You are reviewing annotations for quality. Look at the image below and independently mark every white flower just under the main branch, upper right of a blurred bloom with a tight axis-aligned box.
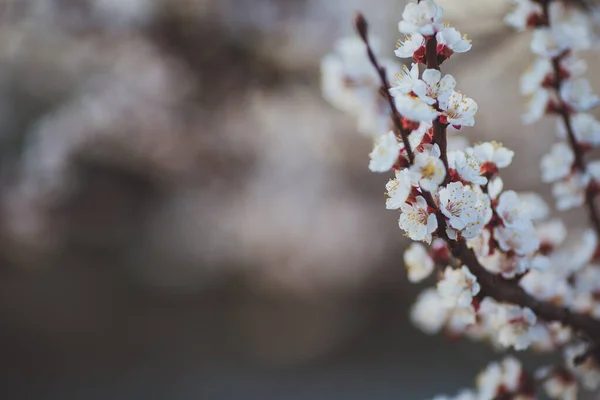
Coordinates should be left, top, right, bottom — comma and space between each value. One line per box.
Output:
437, 265, 481, 308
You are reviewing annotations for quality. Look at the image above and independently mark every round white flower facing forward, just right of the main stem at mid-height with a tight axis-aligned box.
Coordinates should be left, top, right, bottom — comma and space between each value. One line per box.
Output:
439, 182, 481, 230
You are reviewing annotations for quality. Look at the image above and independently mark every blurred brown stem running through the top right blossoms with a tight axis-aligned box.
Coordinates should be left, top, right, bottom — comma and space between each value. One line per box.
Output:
541, 0, 600, 237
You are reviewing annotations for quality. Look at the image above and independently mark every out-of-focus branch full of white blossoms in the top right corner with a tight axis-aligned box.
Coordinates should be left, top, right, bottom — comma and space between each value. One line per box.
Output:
506, 0, 600, 210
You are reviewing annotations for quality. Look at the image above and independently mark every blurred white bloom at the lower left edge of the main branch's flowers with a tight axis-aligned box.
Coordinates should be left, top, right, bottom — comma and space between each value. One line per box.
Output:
410, 288, 450, 335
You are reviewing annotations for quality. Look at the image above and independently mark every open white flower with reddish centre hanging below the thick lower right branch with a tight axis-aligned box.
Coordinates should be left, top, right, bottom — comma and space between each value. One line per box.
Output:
494, 304, 537, 350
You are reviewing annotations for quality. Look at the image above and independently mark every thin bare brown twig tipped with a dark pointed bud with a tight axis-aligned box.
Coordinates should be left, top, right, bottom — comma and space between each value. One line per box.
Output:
354, 13, 415, 163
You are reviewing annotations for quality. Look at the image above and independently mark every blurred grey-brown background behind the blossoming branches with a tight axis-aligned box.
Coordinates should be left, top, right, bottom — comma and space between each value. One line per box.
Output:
0, 0, 600, 400
